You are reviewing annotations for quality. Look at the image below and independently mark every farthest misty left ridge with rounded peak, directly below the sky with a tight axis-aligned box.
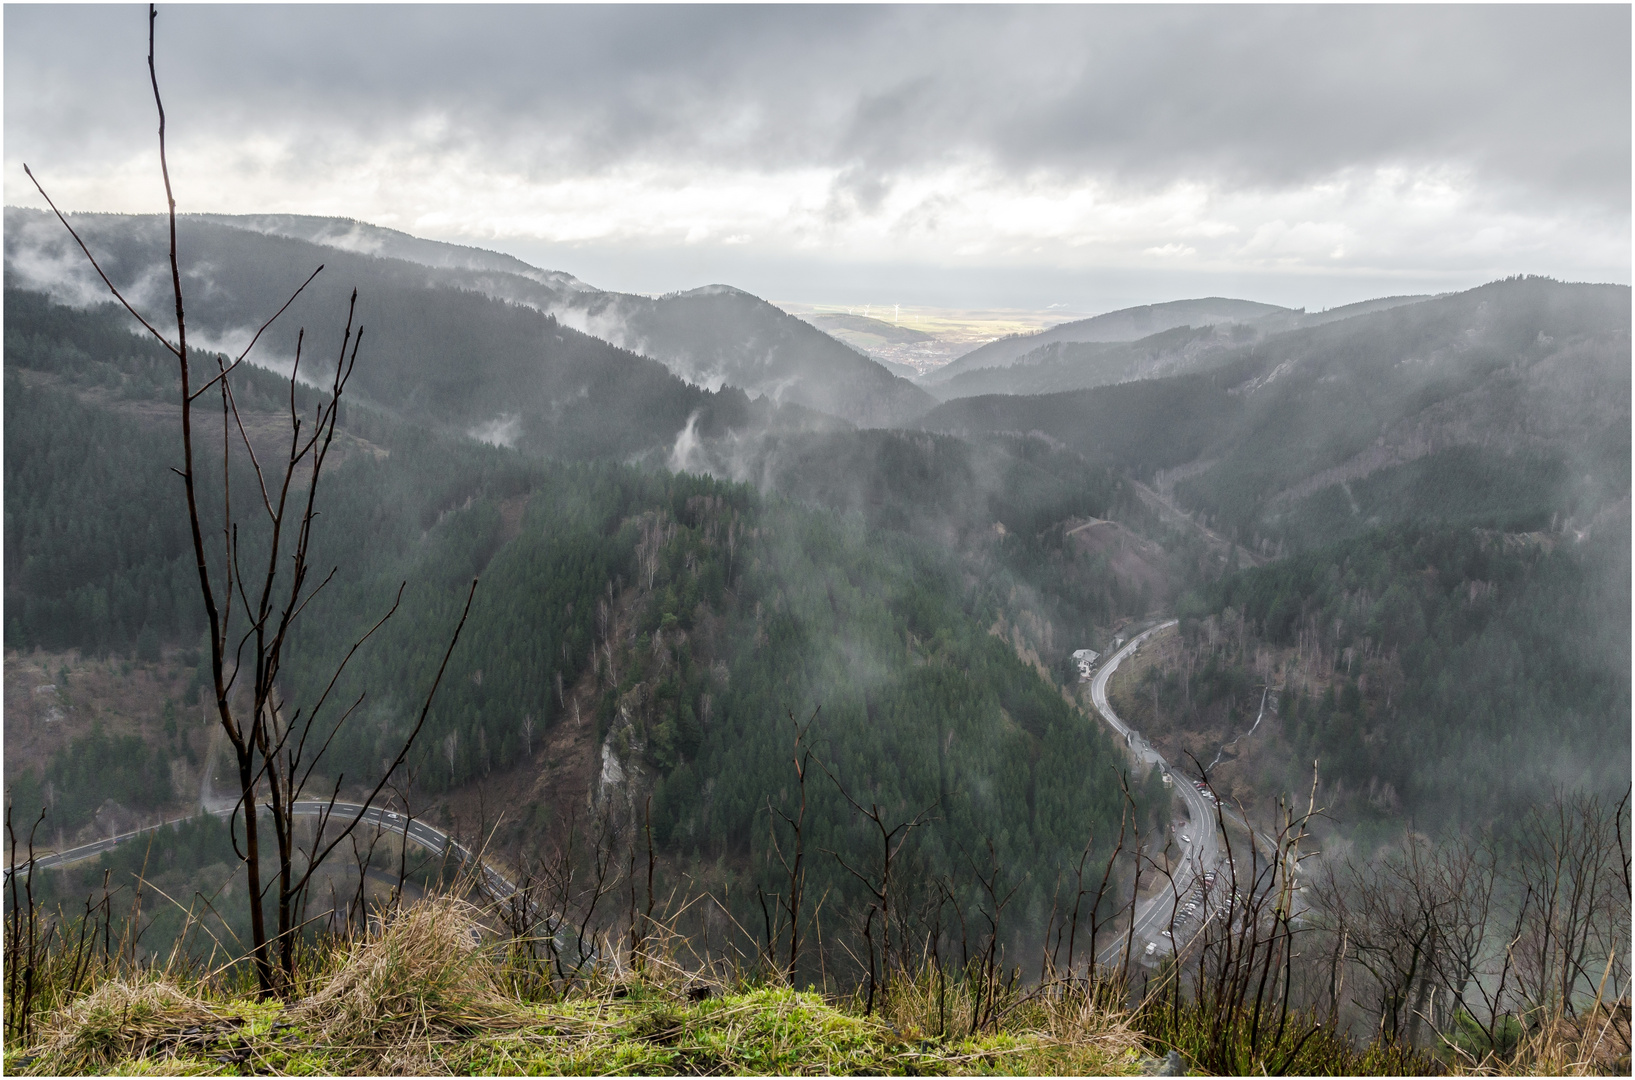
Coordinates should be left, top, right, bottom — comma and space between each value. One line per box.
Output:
31, 208, 935, 425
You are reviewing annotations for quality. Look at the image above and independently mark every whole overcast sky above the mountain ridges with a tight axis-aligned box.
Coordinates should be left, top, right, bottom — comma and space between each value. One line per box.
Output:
5, 5, 1630, 312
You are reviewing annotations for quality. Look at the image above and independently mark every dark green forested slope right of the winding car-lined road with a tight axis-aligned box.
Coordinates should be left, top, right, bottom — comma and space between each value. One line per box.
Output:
1157, 519, 1630, 837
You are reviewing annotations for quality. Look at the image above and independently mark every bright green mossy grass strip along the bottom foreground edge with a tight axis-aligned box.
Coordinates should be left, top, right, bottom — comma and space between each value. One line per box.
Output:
5, 982, 1141, 1077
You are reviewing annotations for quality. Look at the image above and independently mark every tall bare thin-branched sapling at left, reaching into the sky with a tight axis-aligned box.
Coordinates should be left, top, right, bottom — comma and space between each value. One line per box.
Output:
25, 5, 477, 995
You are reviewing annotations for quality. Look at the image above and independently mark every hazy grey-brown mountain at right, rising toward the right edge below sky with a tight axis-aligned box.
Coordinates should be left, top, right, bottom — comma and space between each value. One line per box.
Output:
922, 278, 1630, 542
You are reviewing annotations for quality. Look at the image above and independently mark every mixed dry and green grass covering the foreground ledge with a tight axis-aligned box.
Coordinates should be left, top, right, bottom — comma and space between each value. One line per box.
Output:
5, 895, 1628, 1075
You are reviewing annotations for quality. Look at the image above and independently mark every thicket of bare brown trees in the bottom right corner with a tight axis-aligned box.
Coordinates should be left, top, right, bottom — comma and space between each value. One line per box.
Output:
1313, 794, 1630, 1069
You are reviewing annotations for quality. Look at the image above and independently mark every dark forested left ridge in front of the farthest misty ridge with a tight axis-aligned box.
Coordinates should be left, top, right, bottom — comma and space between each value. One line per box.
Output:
5, 211, 767, 457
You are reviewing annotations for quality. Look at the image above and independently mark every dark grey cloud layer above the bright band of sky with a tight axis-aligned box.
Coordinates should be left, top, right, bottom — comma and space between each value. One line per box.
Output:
5, 5, 1630, 219
